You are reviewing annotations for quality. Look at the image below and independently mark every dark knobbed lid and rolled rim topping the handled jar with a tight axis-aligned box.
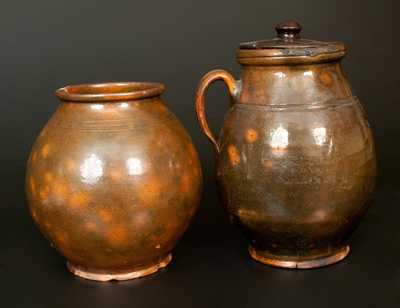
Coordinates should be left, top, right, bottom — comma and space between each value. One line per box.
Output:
238, 20, 346, 64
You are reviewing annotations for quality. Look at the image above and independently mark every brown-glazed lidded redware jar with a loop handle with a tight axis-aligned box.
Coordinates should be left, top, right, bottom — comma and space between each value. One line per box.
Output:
196, 21, 376, 268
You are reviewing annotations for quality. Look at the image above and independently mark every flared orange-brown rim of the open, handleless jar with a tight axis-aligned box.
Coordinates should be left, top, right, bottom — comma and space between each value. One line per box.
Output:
55, 82, 165, 102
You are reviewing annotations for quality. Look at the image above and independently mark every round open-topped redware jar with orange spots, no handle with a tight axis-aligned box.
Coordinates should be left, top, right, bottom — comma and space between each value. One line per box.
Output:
26, 82, 202, 281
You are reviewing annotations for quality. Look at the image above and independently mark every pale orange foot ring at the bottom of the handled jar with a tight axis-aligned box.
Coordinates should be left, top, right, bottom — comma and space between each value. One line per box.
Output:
249, 245, 350, 269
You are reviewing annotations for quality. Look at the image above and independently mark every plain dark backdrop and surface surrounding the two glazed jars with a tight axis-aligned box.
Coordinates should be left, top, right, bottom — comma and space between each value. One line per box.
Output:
0, 0, 400, 308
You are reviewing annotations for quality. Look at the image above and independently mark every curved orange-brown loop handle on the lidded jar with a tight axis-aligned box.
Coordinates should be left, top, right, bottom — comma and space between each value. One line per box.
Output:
196, 70, 239, 154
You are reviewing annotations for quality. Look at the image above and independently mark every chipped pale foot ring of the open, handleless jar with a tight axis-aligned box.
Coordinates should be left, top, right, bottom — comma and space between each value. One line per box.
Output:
67, 254, 172, 281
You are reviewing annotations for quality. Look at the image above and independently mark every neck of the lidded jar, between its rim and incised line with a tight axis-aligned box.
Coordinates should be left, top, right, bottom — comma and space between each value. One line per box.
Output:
238, 61, 352, 105
